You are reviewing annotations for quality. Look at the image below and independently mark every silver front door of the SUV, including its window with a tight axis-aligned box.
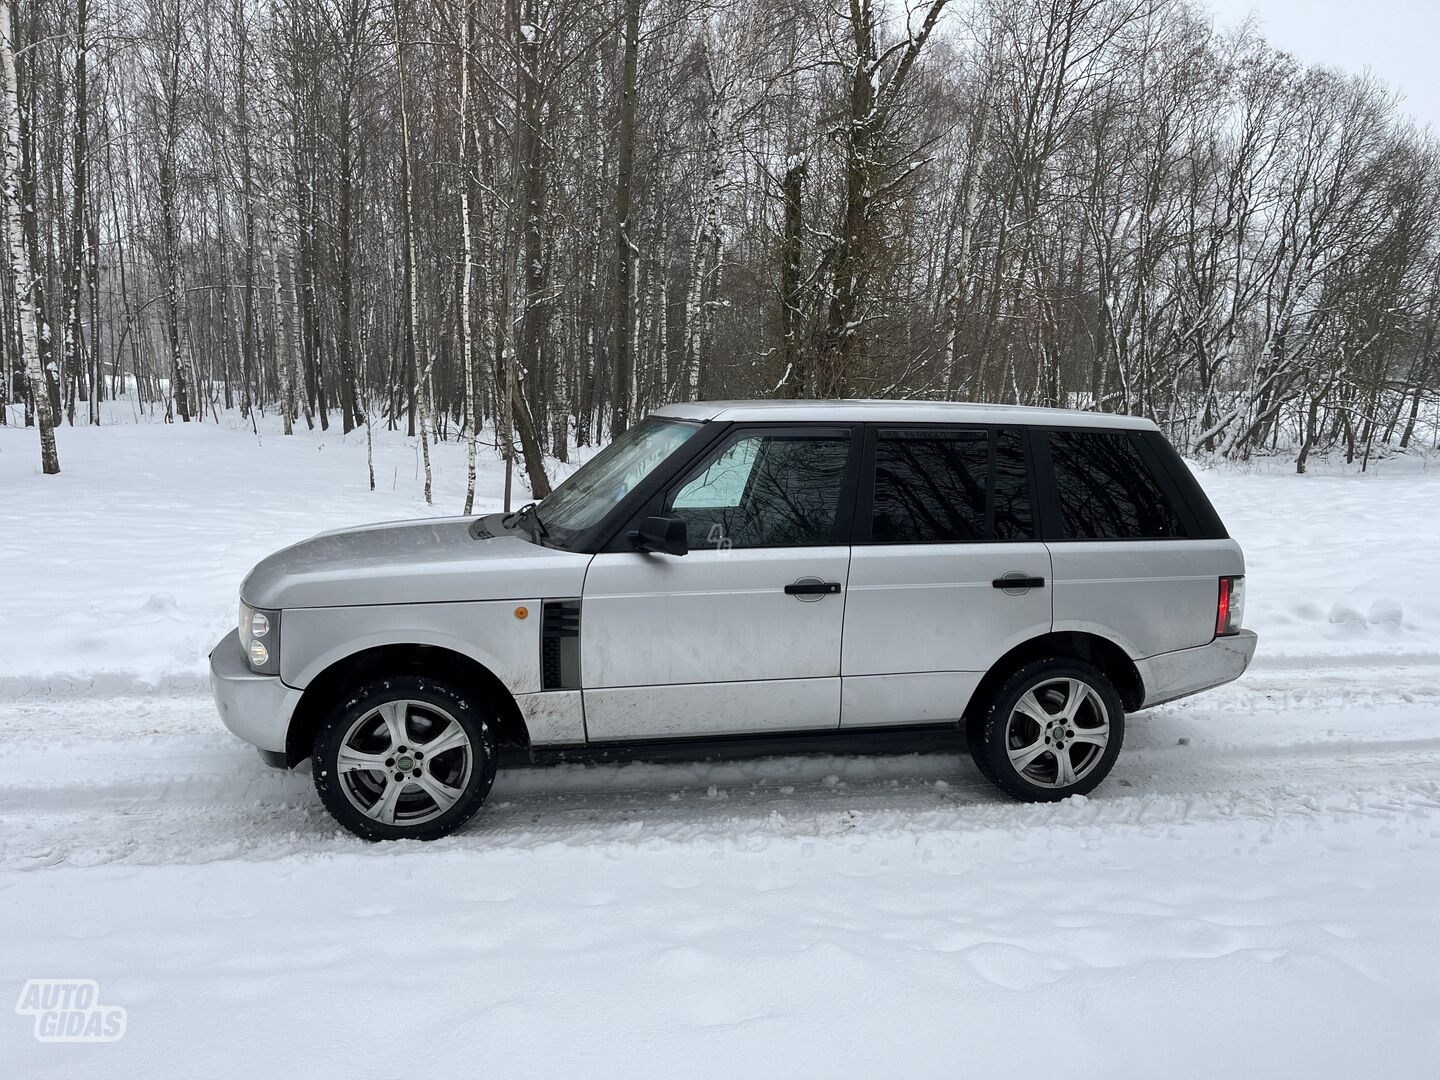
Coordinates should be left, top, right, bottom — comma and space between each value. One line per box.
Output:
580, 426, 857, 742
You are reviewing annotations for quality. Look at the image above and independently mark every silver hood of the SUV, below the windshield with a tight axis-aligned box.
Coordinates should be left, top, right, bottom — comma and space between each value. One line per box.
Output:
240, 516, 590, 609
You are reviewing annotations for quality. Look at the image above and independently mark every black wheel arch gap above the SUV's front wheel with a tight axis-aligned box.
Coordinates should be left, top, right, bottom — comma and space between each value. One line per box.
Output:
285, 645, 530, 769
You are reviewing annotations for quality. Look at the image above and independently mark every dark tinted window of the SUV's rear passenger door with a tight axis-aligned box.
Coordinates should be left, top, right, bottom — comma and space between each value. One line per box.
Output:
870, 428, 1031, 544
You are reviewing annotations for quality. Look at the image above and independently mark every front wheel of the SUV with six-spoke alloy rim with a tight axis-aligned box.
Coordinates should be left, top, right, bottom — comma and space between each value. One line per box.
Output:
314, 675, 497, 840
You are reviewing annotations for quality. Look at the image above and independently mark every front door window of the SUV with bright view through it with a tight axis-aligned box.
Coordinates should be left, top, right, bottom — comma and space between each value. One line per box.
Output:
665, 433, 850, 547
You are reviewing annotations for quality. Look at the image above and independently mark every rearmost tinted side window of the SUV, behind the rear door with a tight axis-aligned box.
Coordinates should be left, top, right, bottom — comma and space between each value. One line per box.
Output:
1048, 431, 1185, 540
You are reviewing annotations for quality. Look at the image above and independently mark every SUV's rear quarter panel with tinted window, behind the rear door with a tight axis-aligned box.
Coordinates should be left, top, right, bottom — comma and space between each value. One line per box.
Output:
1035, 429, 1243, 660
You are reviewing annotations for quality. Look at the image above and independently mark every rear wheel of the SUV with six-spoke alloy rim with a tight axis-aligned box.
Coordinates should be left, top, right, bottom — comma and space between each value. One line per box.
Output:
971, 658, 1125, 802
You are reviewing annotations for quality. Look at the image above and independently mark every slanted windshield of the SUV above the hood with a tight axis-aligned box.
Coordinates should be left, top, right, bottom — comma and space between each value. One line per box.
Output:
539, 416, 700, 544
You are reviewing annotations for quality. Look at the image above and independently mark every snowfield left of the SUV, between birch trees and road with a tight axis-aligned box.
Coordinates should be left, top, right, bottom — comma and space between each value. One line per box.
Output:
0, 408, 555, 690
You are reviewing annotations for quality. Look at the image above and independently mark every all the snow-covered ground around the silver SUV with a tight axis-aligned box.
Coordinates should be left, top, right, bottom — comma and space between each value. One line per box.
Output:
0, 408, 1440, 1080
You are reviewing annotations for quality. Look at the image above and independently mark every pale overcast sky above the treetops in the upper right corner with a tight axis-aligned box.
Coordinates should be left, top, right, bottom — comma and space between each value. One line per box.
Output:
1208, 0, 1440, 131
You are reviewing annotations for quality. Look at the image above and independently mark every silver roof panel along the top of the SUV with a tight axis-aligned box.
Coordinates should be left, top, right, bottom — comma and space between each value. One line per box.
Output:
652, 397, 1156, 431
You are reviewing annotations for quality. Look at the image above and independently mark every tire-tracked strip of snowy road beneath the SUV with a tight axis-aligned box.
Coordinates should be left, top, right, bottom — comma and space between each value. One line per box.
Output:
0, 691, 1440, 870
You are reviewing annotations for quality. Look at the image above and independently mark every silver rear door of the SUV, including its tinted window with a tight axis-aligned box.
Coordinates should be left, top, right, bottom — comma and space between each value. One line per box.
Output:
841, 426, 1051, 727
